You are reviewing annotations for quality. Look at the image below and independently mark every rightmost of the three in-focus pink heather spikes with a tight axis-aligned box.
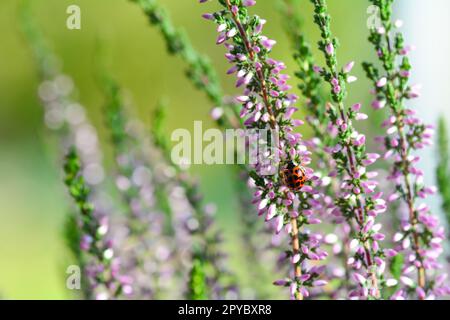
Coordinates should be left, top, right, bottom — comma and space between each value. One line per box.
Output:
363, 0, 445, 300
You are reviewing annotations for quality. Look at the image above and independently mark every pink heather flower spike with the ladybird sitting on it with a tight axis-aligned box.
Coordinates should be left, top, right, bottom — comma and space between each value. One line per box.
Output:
200, 0, 327, 299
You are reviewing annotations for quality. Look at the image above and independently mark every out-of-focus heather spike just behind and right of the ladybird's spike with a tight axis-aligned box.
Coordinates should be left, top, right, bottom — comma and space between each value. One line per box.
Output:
280, 0, 353, 298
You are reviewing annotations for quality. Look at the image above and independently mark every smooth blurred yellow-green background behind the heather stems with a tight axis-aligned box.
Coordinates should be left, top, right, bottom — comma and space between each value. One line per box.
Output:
0, 0, 442, 299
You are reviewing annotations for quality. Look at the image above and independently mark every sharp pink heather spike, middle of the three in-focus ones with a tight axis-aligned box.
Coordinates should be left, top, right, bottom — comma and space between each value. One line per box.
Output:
311, 0, 386, 299
